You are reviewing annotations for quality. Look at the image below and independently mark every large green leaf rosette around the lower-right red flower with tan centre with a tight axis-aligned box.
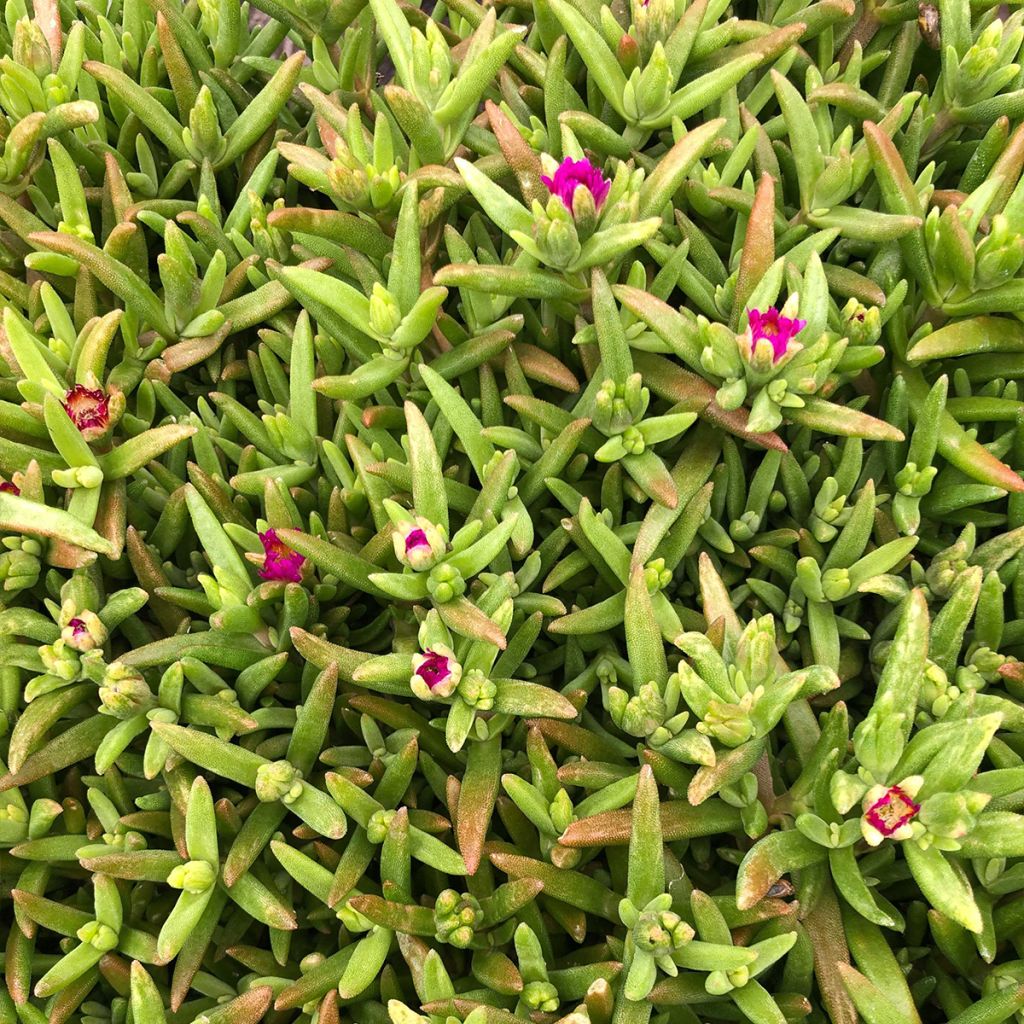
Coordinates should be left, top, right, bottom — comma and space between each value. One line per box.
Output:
737, 591, 1020, 933
